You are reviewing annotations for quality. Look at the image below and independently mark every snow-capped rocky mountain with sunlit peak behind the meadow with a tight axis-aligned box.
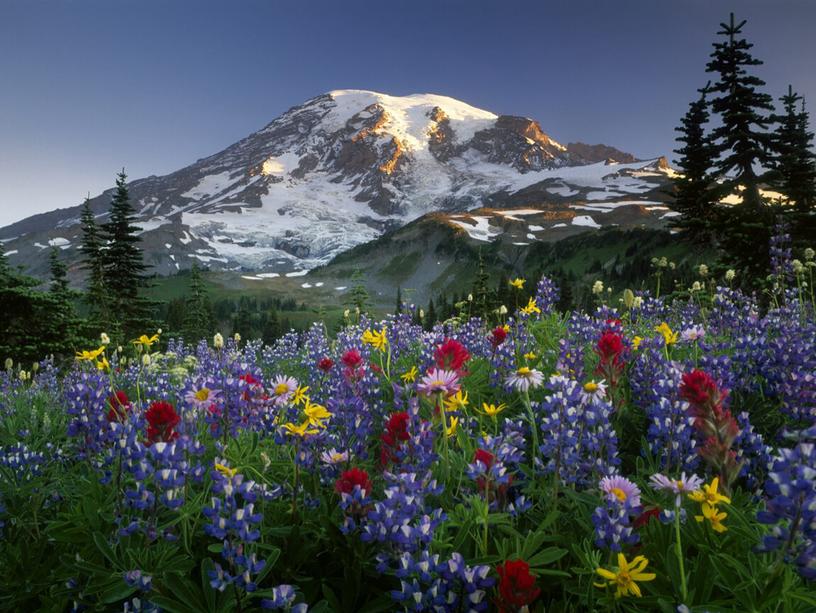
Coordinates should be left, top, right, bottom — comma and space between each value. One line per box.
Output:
0, 90, 670, 273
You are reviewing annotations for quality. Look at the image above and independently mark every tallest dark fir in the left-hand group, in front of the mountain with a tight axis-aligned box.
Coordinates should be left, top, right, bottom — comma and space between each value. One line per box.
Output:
101, 169, 155, 338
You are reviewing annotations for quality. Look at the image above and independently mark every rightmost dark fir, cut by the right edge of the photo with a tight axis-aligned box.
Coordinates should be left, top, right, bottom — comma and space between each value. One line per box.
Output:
773, 85, 816, 213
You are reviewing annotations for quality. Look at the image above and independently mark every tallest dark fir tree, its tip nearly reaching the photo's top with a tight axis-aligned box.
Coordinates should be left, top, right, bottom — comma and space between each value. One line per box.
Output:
706, 13, 774, 210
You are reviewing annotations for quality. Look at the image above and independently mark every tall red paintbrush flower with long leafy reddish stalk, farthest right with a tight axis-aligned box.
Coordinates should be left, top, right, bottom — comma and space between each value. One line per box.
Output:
680, 370, 742, 491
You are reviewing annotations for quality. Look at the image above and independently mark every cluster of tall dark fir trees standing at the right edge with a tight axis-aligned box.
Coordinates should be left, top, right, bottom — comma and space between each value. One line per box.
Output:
673, 13, 816, 288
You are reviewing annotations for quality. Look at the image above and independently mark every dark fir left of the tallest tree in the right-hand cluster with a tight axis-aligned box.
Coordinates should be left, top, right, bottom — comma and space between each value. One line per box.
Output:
670, 86, 717, 242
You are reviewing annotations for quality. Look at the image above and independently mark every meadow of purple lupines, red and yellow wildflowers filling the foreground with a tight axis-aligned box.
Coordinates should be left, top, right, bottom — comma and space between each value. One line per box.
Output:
0, 250, 816, 612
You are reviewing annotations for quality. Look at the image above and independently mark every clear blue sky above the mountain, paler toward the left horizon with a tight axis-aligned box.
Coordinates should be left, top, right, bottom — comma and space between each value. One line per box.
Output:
0, 0, 816, 225
